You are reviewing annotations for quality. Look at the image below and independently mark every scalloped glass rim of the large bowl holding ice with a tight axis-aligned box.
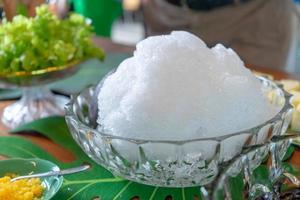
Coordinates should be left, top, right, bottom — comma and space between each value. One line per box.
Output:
65, 76, 293, 144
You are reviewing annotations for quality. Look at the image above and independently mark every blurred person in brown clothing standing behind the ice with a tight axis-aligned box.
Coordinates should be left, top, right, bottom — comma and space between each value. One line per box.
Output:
142, 0, 292, 68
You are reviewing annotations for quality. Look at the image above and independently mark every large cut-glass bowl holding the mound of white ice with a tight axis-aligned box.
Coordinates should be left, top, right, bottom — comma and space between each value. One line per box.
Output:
66, 77, 292, 187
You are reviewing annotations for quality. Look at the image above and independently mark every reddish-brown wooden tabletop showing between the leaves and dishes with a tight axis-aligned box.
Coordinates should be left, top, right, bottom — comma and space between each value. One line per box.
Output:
0, 38, 300, 175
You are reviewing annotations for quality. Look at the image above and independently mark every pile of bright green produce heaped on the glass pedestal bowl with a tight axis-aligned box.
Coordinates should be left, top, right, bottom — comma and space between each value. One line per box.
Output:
0, 5, 104, 73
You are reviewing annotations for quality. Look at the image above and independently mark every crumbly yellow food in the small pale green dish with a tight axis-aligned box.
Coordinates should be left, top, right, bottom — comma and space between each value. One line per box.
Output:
0, 175, 44, 200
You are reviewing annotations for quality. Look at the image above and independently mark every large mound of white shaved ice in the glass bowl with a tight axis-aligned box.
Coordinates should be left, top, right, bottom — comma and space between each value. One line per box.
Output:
97, 31, 279, 140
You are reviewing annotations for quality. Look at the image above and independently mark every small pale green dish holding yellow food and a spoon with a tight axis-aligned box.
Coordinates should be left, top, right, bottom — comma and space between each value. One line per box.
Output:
0, 158, 63, 200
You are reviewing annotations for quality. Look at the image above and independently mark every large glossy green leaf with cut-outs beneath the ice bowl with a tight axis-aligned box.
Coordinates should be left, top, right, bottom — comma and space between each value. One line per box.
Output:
0, 117, 300, 200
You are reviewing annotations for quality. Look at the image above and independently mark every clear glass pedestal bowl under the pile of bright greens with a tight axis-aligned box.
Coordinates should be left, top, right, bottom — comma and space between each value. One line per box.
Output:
0, 61, 79, 128
